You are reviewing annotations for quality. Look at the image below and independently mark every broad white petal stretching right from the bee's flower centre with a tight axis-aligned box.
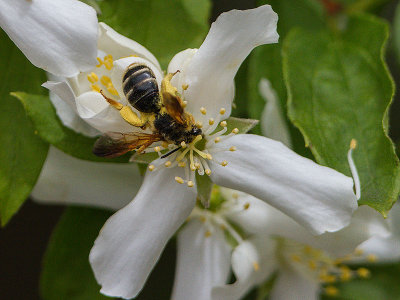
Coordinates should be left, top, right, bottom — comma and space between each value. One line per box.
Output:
210, 134, 357, 234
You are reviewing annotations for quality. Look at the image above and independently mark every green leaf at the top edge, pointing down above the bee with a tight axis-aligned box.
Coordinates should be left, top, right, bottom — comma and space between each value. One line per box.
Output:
99, 0, 211, 69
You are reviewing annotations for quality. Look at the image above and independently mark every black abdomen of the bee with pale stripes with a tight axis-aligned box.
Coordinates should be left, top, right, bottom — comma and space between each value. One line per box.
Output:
122, 63, 161, 113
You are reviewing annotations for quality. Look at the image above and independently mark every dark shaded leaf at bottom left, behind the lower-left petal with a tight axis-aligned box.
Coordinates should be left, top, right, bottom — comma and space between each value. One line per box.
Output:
40, 207, 111, 300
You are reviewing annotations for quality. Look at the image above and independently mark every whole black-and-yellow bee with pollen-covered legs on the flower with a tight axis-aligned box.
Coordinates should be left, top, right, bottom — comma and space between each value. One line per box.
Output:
93, 63, 202, 157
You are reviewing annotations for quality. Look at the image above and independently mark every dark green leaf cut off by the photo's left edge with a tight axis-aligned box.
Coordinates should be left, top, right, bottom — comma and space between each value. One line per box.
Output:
0, 30, 48, 226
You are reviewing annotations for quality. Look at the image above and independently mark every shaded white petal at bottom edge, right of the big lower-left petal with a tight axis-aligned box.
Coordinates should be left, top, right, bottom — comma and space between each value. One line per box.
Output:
172, 219, 231, 300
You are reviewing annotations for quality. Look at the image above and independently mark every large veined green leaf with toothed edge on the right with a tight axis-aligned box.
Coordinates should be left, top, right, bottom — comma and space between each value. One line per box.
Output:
283, 15, 400, 214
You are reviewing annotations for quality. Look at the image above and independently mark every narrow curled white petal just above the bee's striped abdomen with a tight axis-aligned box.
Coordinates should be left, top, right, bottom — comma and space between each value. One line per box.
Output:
98, 22, 161, 70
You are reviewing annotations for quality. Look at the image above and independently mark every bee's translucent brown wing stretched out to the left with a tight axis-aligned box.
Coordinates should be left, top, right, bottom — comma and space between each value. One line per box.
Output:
93, 132, 161, 158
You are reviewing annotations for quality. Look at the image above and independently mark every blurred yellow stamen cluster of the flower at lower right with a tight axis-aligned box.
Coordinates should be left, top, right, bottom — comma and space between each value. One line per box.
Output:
284, 240, 376, 296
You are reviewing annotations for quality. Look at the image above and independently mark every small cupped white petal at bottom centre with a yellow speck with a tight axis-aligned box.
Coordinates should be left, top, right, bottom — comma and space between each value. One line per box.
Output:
212, 236, 277, 300
